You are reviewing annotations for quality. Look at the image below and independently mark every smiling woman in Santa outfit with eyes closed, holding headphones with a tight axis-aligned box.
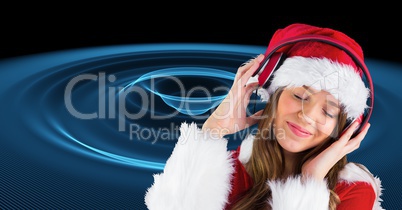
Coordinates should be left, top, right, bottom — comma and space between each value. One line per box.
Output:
145, 24, 382, 210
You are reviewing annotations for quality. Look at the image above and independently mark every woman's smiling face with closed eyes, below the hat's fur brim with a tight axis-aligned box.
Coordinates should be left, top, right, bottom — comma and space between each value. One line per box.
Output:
274, 86, 340, 153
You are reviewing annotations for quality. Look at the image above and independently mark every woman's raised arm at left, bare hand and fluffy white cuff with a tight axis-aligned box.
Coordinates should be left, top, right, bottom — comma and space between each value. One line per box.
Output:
145, 55, 264, 210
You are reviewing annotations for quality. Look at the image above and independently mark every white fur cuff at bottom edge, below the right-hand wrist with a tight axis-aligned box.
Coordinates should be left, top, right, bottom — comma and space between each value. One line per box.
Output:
268, 176, 330, 210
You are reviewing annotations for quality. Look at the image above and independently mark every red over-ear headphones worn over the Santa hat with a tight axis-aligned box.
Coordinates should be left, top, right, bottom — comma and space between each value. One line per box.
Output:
253, 35, 374, 138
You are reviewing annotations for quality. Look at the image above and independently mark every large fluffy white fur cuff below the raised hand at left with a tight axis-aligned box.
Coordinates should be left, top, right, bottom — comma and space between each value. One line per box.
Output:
145, 123, 234, 210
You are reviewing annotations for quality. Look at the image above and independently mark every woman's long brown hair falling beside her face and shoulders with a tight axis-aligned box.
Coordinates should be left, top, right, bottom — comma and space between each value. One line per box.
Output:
232, 88, 347, 210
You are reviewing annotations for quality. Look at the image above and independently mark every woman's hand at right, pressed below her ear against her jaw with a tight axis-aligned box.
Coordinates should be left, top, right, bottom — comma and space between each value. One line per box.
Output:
302, 122, 370, 180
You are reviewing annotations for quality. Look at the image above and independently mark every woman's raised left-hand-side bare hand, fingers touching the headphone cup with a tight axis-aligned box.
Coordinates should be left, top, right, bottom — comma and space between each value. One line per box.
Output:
202, 55, 264, 137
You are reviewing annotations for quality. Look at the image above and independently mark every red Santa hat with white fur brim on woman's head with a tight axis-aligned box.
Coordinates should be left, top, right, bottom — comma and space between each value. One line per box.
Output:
254, 23, 370, 119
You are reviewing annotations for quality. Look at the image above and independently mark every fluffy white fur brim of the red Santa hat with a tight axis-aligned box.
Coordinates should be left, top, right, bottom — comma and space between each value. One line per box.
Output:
257, 56, 370, 119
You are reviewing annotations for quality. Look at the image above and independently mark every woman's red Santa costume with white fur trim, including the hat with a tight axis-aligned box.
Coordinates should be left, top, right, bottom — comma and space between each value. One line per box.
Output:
145, 24, 383, 210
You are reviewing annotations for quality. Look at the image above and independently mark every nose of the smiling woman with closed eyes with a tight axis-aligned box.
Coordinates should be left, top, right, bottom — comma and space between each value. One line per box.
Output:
298, 103, 325, 126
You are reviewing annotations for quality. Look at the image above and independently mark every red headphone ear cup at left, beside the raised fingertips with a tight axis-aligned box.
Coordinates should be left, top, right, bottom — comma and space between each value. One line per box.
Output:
258, 52, 286, 88
